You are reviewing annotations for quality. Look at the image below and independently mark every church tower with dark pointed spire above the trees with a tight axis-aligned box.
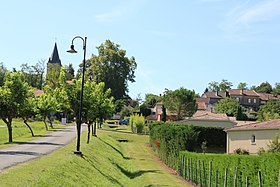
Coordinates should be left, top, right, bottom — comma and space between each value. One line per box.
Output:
46, 42, 61, 88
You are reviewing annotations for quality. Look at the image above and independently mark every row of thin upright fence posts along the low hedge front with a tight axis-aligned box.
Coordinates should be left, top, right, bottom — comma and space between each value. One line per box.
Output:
179, 155, 280, 187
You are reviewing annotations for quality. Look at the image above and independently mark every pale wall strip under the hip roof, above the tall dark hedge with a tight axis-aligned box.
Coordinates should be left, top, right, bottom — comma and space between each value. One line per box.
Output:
179, 119, 235, 129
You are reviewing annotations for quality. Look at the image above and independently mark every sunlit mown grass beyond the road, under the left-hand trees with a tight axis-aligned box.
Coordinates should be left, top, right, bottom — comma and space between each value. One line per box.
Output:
0, 119, 68, 148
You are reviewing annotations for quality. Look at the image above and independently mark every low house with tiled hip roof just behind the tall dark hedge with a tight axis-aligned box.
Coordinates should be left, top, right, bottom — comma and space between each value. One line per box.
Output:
176, 111, 236, 129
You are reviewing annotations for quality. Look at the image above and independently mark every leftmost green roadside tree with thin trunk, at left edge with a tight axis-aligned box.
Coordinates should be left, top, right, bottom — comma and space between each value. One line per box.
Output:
0, 72, 29, 142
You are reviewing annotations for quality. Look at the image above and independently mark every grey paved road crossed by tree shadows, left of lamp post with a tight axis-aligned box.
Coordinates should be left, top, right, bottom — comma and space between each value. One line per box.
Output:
0, 126, 85, 172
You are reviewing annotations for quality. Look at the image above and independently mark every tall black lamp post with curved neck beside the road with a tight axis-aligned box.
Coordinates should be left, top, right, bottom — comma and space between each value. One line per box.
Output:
67, 36, 87, 155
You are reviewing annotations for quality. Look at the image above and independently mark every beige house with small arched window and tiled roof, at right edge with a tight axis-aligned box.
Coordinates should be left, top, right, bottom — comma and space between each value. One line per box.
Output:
225, 120, 280, 154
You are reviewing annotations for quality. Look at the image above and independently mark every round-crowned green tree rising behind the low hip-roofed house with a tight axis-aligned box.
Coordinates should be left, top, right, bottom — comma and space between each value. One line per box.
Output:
163, 87, 197, 120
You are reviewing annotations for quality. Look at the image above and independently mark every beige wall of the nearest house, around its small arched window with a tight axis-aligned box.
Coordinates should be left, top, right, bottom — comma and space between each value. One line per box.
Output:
227, 129, 280, 154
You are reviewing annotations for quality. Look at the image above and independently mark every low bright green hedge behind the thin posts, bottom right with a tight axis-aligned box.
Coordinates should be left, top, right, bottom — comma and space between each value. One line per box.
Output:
178, 151, 280, 186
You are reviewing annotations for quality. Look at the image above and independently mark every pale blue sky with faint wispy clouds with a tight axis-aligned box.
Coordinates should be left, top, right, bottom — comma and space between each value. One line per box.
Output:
0, 0, 280, 99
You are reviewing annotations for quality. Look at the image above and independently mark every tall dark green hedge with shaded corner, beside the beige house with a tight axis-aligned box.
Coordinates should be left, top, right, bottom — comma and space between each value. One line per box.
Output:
149, 122, 226, 169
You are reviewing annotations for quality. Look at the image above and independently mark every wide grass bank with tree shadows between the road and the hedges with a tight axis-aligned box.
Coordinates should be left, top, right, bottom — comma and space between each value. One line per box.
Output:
0, 130, 188, 187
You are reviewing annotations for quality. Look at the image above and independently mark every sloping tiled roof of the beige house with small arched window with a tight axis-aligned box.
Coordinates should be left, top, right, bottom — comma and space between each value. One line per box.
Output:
227, 119, 280, 131
